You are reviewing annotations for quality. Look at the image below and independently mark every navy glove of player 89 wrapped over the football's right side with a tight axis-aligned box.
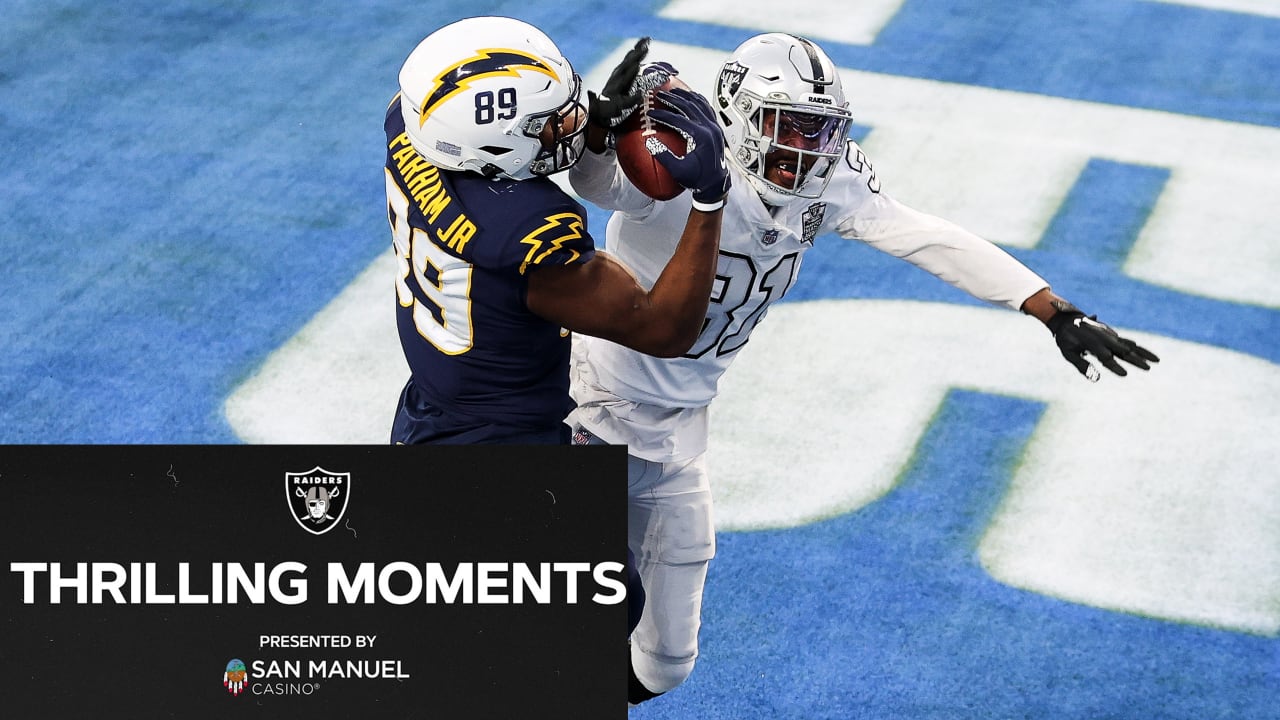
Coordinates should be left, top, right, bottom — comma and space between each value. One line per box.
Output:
645, 87, 730, 209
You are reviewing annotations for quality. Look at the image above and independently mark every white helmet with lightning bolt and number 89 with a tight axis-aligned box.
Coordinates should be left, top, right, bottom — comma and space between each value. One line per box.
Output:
399, 17, 586, 179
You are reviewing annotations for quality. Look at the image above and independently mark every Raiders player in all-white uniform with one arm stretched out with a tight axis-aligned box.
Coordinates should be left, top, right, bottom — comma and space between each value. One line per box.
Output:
566, 33, 1158, 703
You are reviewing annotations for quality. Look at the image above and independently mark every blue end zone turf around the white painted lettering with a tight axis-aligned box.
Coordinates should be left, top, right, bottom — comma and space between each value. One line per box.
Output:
0, 0, 1280, 720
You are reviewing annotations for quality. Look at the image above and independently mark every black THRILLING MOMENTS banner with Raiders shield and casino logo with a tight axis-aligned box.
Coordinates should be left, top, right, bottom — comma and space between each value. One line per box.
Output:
0, 446, 626, 719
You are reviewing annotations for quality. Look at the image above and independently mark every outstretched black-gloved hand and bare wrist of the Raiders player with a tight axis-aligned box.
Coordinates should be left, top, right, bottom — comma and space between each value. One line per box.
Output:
1023, 288, 1160, 382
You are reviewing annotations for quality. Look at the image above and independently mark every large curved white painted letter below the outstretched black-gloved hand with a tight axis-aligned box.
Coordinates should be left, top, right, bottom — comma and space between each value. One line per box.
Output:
708, 300, 1280, 635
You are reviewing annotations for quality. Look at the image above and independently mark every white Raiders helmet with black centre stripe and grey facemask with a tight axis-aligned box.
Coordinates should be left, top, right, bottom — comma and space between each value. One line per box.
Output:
716, 32, 851, 205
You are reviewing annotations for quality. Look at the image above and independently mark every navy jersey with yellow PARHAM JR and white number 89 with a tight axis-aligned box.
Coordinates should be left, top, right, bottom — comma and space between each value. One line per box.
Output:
385, 101, 595, 442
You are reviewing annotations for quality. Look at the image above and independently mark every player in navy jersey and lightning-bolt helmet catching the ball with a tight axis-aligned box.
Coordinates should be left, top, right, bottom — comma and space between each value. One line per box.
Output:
385, 17, 728, 445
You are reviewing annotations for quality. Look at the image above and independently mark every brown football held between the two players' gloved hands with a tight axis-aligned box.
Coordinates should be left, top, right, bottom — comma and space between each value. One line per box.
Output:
613, 63, 706, 200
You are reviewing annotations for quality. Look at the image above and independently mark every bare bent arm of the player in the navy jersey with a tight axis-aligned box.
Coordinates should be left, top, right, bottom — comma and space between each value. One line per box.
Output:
526, 209, 723, 357
